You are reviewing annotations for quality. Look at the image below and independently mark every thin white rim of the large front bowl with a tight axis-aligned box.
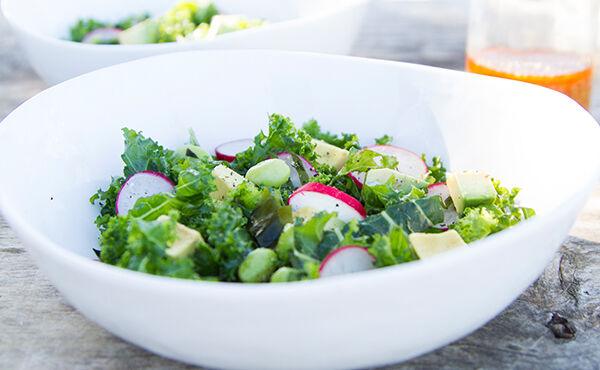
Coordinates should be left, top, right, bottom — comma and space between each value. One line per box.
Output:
0, 50, 600, 295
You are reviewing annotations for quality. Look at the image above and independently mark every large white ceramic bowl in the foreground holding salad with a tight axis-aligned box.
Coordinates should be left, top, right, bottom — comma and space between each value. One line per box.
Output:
0, 51, 600, 369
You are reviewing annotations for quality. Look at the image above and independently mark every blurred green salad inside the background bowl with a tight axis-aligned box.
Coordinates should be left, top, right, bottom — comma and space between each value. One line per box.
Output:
70, 0, 265, 44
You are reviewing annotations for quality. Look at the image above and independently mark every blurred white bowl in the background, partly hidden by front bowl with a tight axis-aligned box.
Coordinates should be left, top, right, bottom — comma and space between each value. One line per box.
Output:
0, 0, 369, 84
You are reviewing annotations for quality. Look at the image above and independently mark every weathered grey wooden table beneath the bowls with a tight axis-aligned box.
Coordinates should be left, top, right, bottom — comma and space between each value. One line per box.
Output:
0, 1, 600, 369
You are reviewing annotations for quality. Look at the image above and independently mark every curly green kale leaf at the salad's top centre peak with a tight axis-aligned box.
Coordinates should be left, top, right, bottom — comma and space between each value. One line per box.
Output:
231, 114, 317, 175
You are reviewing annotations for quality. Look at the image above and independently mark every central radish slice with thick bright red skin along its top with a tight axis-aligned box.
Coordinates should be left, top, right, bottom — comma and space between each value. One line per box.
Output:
288, 182, 367, 222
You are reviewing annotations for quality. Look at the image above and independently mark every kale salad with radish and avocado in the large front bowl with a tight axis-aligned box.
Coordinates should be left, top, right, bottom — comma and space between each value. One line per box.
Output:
90, 114, 535, 283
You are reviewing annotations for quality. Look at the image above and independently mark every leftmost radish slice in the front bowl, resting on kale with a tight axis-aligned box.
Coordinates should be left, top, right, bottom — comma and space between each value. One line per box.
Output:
115, 171, 175, 215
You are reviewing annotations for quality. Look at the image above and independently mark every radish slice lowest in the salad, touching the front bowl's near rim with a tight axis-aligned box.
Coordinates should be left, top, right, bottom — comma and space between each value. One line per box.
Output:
319, 245, 375, 278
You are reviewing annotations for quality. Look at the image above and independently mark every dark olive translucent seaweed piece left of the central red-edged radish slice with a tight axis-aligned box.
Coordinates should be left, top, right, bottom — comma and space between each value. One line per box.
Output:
249, 192, 292, 248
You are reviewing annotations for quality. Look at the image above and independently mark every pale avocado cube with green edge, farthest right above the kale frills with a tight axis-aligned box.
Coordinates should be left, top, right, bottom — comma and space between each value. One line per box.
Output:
446, 172, 498, 214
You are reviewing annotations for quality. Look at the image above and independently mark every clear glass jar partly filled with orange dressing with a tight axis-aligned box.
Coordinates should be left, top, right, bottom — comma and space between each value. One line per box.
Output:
465, 0, 598, 109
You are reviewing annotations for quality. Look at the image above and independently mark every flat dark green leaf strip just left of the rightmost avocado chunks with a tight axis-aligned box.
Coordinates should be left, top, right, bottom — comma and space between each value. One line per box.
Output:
358, 196, 444, 236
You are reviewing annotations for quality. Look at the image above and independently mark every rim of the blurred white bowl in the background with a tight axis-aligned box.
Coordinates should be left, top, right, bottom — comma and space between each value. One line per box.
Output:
0, 0, 371, 53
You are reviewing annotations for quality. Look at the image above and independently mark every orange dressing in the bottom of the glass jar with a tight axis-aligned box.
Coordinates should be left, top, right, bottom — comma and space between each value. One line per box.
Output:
466, 48, 593, 109
